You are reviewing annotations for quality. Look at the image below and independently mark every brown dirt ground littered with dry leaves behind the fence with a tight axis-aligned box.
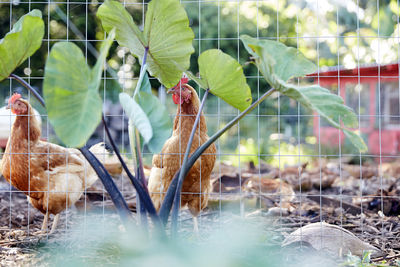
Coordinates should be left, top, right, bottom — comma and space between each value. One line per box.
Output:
0, 161, 400, 266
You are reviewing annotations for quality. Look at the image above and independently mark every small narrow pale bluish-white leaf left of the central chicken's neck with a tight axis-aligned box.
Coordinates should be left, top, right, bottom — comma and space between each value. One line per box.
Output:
119, 93, 153, 143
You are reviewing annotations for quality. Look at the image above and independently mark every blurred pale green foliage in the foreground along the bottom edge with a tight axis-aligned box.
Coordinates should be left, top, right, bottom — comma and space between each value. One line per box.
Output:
40, 215, 338, 267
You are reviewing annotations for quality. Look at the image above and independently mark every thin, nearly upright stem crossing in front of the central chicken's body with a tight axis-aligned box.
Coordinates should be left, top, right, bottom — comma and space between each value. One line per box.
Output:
171, 89, 210, 234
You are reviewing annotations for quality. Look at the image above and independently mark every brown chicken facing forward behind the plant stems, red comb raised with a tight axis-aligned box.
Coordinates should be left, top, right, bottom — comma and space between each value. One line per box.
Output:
148, 79, 216, 231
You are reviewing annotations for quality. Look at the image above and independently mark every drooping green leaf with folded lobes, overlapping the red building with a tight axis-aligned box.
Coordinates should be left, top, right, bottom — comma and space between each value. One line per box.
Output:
241, 35, 367, 151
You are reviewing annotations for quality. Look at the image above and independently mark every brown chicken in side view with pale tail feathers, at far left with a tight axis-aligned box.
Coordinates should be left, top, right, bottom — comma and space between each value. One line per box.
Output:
1, 94, 120, 233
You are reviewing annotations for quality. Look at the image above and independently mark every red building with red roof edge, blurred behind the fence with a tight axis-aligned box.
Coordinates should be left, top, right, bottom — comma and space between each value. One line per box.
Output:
309, 64, 400, 155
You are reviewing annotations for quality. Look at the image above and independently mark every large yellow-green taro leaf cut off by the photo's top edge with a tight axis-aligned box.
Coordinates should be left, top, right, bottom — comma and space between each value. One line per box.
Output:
97, 0, 194, 88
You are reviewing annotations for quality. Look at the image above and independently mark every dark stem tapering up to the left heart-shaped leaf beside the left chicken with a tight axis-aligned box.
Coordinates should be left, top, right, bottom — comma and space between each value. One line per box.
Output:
102, 116, 161, 229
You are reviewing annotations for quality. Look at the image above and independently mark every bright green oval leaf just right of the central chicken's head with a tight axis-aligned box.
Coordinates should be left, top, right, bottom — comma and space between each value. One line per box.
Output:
195, 49, 251, 111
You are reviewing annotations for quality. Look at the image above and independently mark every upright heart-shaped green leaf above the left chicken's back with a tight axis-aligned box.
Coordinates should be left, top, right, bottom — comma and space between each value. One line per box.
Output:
43, 31, 114, 147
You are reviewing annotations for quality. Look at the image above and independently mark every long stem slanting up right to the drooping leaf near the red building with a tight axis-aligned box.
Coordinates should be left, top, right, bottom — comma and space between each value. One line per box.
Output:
159, 88, 276, 224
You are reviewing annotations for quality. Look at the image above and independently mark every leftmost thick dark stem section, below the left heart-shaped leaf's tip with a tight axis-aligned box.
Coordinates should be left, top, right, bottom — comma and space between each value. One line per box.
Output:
79, 147, 131, 221
